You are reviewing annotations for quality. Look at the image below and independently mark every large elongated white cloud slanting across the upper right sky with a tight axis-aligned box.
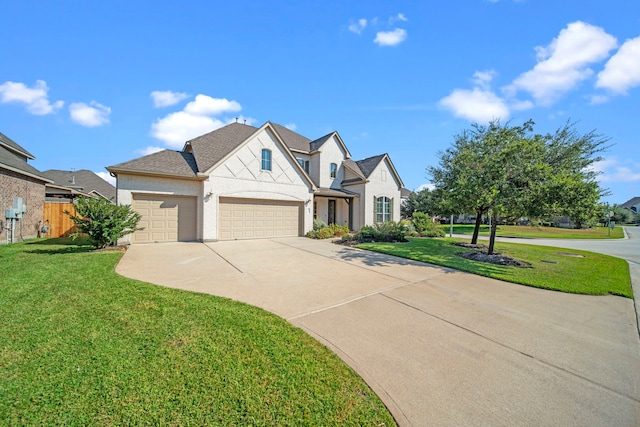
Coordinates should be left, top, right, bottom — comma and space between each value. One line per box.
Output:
504, 21, 617, 105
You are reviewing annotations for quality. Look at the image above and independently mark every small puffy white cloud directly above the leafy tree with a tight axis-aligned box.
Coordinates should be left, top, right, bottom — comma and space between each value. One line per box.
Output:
439, 87, 509, 123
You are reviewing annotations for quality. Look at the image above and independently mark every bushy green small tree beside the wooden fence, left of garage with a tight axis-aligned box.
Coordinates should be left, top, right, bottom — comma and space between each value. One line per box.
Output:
65, 197, 141, 248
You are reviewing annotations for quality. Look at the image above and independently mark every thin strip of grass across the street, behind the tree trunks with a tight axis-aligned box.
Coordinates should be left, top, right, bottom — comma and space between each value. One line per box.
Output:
442, 224, 624, 239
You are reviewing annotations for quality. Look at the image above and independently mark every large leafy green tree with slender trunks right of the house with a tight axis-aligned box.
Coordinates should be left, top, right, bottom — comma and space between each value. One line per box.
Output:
427, 120, 607, 254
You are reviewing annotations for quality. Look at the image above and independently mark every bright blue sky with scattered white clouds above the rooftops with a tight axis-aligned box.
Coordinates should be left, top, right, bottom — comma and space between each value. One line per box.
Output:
0, 0, 640, 203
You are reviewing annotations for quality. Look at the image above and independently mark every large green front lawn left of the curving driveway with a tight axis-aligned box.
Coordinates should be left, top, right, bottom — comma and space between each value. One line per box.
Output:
0, 239, 395, 426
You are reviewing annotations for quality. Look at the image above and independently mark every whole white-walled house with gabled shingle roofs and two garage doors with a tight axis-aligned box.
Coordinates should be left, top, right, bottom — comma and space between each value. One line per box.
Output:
107, 122, 403, 243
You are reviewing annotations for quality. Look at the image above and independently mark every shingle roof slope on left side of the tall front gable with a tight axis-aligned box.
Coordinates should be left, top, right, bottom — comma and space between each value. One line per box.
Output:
185, 123, 258, 172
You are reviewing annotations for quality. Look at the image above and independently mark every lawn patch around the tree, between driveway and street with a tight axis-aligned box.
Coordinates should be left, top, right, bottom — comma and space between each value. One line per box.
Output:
357, 238, 633, 298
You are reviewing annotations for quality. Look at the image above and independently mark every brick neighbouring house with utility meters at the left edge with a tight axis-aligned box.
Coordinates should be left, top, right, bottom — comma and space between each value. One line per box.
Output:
0, 133, 52, 243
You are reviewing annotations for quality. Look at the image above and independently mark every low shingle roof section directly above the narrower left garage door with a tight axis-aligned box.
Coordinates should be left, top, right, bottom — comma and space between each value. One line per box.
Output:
107, 150, 198, 178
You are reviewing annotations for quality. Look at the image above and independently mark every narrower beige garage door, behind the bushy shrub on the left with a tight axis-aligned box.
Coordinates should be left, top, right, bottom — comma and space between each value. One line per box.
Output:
131, 194, 196, 243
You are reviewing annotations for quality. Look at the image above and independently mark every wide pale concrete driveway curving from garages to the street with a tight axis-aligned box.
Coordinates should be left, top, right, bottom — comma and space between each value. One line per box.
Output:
116, 238, 640, 426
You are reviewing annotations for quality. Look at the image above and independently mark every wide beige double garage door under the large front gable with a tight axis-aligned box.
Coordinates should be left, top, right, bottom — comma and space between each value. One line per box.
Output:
218, 197, 302, 240
